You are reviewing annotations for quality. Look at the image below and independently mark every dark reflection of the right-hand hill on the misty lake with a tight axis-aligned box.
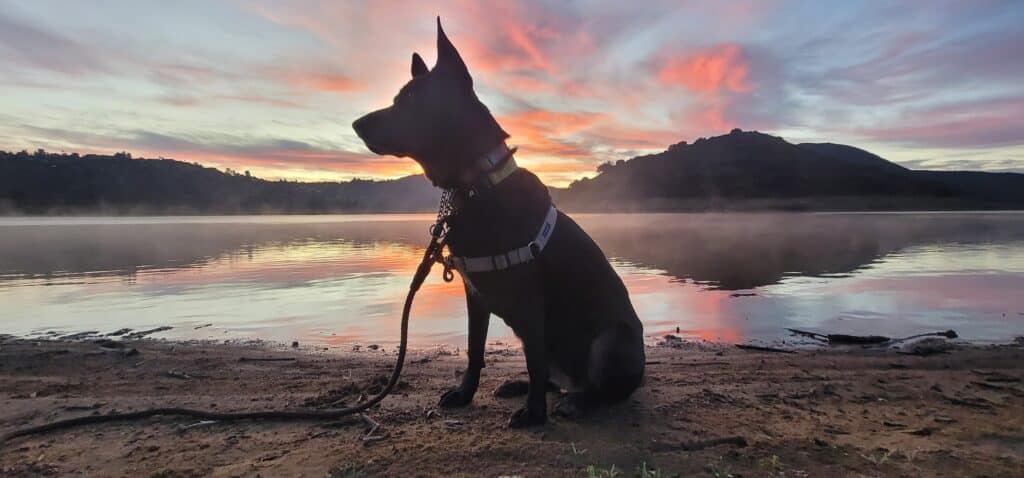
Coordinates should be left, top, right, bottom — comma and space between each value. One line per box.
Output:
580, 213, 1024, 290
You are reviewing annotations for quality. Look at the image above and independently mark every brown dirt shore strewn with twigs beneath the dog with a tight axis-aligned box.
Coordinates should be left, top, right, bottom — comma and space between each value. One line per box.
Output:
0, 338, 1024, 477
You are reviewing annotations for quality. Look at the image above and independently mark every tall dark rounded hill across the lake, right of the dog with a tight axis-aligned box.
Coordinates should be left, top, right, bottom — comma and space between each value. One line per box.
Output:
558, 129, 1024, 210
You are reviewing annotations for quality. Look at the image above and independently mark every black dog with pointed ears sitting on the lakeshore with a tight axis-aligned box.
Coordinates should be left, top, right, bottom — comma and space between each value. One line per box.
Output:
352, 18, 644, 427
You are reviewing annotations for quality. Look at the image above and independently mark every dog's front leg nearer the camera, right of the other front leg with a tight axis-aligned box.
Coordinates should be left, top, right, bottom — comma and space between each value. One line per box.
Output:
509, 294, 550, 428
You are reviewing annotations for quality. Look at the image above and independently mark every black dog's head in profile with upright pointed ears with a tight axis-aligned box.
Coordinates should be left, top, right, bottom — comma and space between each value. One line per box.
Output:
352, 17, 508, 187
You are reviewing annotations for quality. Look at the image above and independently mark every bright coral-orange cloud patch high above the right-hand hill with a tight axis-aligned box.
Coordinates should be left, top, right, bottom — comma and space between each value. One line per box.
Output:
657, 43, 751, 93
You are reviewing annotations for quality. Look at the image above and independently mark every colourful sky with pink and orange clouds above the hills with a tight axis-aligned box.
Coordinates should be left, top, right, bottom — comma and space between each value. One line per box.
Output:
0, 0, 1024, 185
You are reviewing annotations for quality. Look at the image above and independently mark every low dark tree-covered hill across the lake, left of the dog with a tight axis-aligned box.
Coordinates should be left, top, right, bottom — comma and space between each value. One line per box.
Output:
0, 150, 439, 214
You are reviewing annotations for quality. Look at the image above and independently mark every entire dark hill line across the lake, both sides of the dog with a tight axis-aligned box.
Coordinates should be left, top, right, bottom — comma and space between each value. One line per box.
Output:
0, 129, 1024, 214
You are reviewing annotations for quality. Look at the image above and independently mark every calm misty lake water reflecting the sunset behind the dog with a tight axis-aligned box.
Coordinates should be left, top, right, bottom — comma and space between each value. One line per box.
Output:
0, 213, 1024, 346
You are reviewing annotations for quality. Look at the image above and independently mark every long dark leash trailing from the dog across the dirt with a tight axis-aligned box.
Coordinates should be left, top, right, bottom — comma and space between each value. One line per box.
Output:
0, 193, 452, 446
